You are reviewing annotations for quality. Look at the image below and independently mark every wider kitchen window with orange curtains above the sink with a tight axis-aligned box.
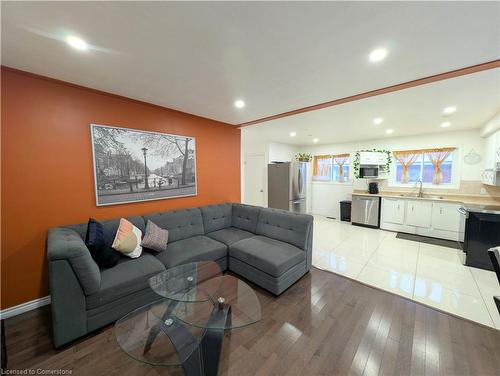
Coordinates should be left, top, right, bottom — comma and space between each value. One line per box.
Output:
392, 148, 456, 187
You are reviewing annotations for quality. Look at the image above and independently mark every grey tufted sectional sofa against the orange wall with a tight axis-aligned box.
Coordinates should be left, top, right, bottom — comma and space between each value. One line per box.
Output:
47, 203, 313, 347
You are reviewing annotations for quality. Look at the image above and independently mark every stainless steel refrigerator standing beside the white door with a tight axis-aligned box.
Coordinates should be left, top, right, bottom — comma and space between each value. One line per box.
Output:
267, 162, 307, 213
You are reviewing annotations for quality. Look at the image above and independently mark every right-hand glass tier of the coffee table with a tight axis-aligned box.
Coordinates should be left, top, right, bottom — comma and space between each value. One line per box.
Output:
172, 275, 261, 330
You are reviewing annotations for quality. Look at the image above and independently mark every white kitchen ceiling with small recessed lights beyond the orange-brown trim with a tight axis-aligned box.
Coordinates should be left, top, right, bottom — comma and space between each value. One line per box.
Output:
244, 68, 500, 145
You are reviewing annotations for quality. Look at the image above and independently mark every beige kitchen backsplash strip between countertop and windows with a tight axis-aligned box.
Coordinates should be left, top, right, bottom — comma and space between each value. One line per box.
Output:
353, 179, 500, 197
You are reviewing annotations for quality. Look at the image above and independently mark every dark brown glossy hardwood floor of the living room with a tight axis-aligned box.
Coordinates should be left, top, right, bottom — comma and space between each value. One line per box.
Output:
5, 268, 500, 376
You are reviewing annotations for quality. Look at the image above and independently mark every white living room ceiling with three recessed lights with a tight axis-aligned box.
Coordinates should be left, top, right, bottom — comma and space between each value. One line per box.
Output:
1, 1, 500, 124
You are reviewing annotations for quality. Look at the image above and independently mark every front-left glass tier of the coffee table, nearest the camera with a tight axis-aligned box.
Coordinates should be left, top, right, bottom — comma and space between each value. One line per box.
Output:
115, 300, 204, 366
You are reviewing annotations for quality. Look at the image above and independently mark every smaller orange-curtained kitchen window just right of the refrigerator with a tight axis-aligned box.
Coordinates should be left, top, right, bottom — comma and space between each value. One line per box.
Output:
313, 154, 350, 183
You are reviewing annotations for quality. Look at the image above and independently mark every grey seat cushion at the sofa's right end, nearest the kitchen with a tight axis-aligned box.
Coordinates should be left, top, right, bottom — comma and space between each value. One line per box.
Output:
229, 236, 306, 277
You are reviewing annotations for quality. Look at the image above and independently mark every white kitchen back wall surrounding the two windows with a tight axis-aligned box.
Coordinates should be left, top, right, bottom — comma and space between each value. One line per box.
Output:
299, 130, 484, 218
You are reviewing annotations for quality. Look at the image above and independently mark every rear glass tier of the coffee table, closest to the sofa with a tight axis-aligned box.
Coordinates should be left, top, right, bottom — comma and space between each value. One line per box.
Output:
149, 261, 222, 302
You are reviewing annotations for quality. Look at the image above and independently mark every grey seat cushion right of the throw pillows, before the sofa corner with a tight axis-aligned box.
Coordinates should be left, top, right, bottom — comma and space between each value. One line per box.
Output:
156, 236, 227, 268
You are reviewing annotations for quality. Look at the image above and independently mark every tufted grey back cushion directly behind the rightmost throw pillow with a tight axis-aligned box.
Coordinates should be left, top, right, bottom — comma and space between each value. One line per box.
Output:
144, 208, 204, 243
